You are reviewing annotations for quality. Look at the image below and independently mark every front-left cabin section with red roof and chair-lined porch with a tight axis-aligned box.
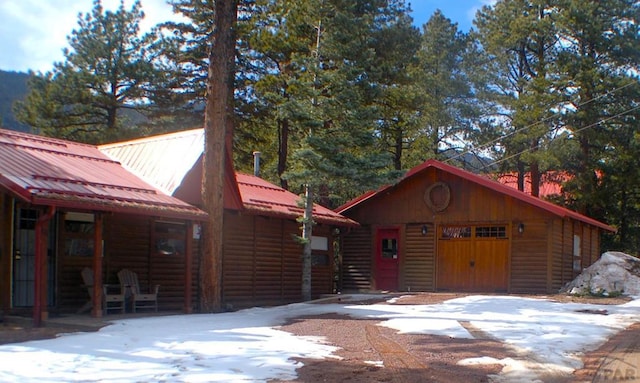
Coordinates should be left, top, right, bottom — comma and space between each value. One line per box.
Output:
0, 129, 206, 326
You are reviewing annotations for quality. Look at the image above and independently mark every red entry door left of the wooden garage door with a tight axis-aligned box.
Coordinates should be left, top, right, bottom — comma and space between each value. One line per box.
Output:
376, 229, 400, 291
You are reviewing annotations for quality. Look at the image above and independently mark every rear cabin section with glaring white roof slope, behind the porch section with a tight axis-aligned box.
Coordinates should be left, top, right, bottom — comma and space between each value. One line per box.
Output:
100, 129, 357, 309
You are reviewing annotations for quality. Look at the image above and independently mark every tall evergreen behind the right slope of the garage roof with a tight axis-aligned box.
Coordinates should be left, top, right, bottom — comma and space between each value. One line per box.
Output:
475, 0, 560, 196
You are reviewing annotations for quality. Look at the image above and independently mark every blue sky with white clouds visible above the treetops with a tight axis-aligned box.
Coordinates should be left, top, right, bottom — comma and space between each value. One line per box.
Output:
0, 0, 495, 72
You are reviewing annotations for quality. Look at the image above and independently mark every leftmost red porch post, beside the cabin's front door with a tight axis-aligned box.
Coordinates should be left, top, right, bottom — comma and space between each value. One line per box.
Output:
33, 206, 56, 327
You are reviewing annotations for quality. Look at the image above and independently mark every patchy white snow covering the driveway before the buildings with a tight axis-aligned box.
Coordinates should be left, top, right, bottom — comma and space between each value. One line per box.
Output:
0, 253, 640, 383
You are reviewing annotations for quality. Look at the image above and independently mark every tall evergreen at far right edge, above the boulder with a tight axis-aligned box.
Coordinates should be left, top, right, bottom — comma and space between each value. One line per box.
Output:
558, 0, 640, 252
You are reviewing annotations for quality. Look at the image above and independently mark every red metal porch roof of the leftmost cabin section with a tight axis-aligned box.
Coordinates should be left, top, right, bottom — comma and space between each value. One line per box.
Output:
0, 129, 206, 219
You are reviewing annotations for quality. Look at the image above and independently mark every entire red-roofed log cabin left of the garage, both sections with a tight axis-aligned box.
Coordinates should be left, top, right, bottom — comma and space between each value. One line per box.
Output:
0, 129, 356, 325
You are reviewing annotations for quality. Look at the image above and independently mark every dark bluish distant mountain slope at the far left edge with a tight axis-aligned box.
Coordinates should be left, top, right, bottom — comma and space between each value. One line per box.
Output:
0, 70, 30, 132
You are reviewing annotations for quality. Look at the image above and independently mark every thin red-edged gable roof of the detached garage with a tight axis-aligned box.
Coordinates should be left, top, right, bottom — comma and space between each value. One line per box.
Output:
335, 159, 616, 232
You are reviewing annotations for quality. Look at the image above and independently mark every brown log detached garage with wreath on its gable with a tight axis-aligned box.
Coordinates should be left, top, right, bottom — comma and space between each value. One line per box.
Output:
336, 160, 615, 293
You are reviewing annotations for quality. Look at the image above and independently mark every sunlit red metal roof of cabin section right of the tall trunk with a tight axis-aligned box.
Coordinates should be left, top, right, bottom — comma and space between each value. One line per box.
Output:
236, 173, 358, 226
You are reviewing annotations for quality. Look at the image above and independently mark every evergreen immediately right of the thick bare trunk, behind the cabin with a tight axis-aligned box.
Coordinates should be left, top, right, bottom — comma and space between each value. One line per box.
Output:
238, 0, 321, 189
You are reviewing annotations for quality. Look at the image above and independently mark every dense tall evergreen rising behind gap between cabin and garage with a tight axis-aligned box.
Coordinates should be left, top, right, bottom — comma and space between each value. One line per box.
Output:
282, 0, 407, 206
